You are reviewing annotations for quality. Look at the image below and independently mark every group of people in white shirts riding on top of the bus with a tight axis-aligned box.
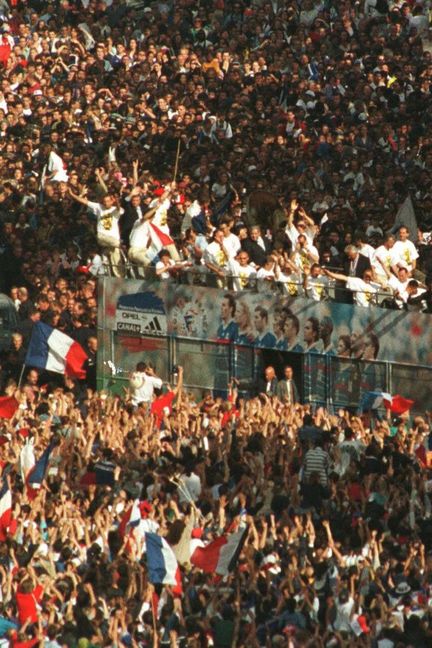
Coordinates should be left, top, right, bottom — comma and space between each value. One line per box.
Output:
70, 173, 425, 307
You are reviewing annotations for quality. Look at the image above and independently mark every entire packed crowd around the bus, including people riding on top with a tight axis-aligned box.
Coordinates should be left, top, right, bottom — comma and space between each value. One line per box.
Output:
0, 0, 432, 648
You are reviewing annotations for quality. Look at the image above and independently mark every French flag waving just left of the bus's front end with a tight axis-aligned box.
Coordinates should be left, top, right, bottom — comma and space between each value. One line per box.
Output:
25, 322, 87, 378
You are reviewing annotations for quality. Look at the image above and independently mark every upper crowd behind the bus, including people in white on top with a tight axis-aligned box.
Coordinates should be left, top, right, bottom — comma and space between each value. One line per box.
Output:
0, 0, 432, 309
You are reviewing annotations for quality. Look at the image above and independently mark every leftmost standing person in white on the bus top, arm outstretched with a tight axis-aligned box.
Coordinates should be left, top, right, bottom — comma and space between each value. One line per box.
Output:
69, 187, 124, 277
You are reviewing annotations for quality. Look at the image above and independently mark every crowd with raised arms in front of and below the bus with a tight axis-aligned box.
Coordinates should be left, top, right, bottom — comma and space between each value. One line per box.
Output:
0, 363, 432, 648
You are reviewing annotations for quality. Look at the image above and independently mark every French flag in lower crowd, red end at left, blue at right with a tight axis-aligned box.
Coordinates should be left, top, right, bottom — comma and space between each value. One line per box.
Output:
191, 527, 248, 576
